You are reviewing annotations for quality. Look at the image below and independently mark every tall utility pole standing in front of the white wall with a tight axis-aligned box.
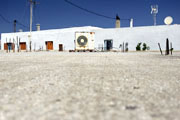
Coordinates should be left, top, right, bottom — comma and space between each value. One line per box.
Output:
29, 0, 38, 51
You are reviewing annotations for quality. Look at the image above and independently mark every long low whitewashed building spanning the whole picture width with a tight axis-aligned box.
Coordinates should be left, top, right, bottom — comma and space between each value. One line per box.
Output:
1, 25, 180, 51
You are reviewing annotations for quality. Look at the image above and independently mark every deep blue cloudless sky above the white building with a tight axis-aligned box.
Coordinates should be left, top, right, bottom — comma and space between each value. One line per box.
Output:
0, 0, 180, 33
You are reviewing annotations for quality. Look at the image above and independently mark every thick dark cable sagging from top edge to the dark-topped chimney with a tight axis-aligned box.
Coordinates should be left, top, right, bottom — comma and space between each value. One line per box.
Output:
64, 0, 116, 20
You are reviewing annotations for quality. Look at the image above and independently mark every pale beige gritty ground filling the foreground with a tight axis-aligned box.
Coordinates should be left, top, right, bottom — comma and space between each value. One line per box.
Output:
0, 51, 180, 120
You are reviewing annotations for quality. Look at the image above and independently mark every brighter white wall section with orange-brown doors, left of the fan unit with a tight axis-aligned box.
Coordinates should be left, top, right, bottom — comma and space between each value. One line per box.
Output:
2, 26, 101, 50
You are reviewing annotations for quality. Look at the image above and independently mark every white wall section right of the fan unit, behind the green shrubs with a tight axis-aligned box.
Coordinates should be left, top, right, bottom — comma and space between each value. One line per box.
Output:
95, 25, 180, 51
